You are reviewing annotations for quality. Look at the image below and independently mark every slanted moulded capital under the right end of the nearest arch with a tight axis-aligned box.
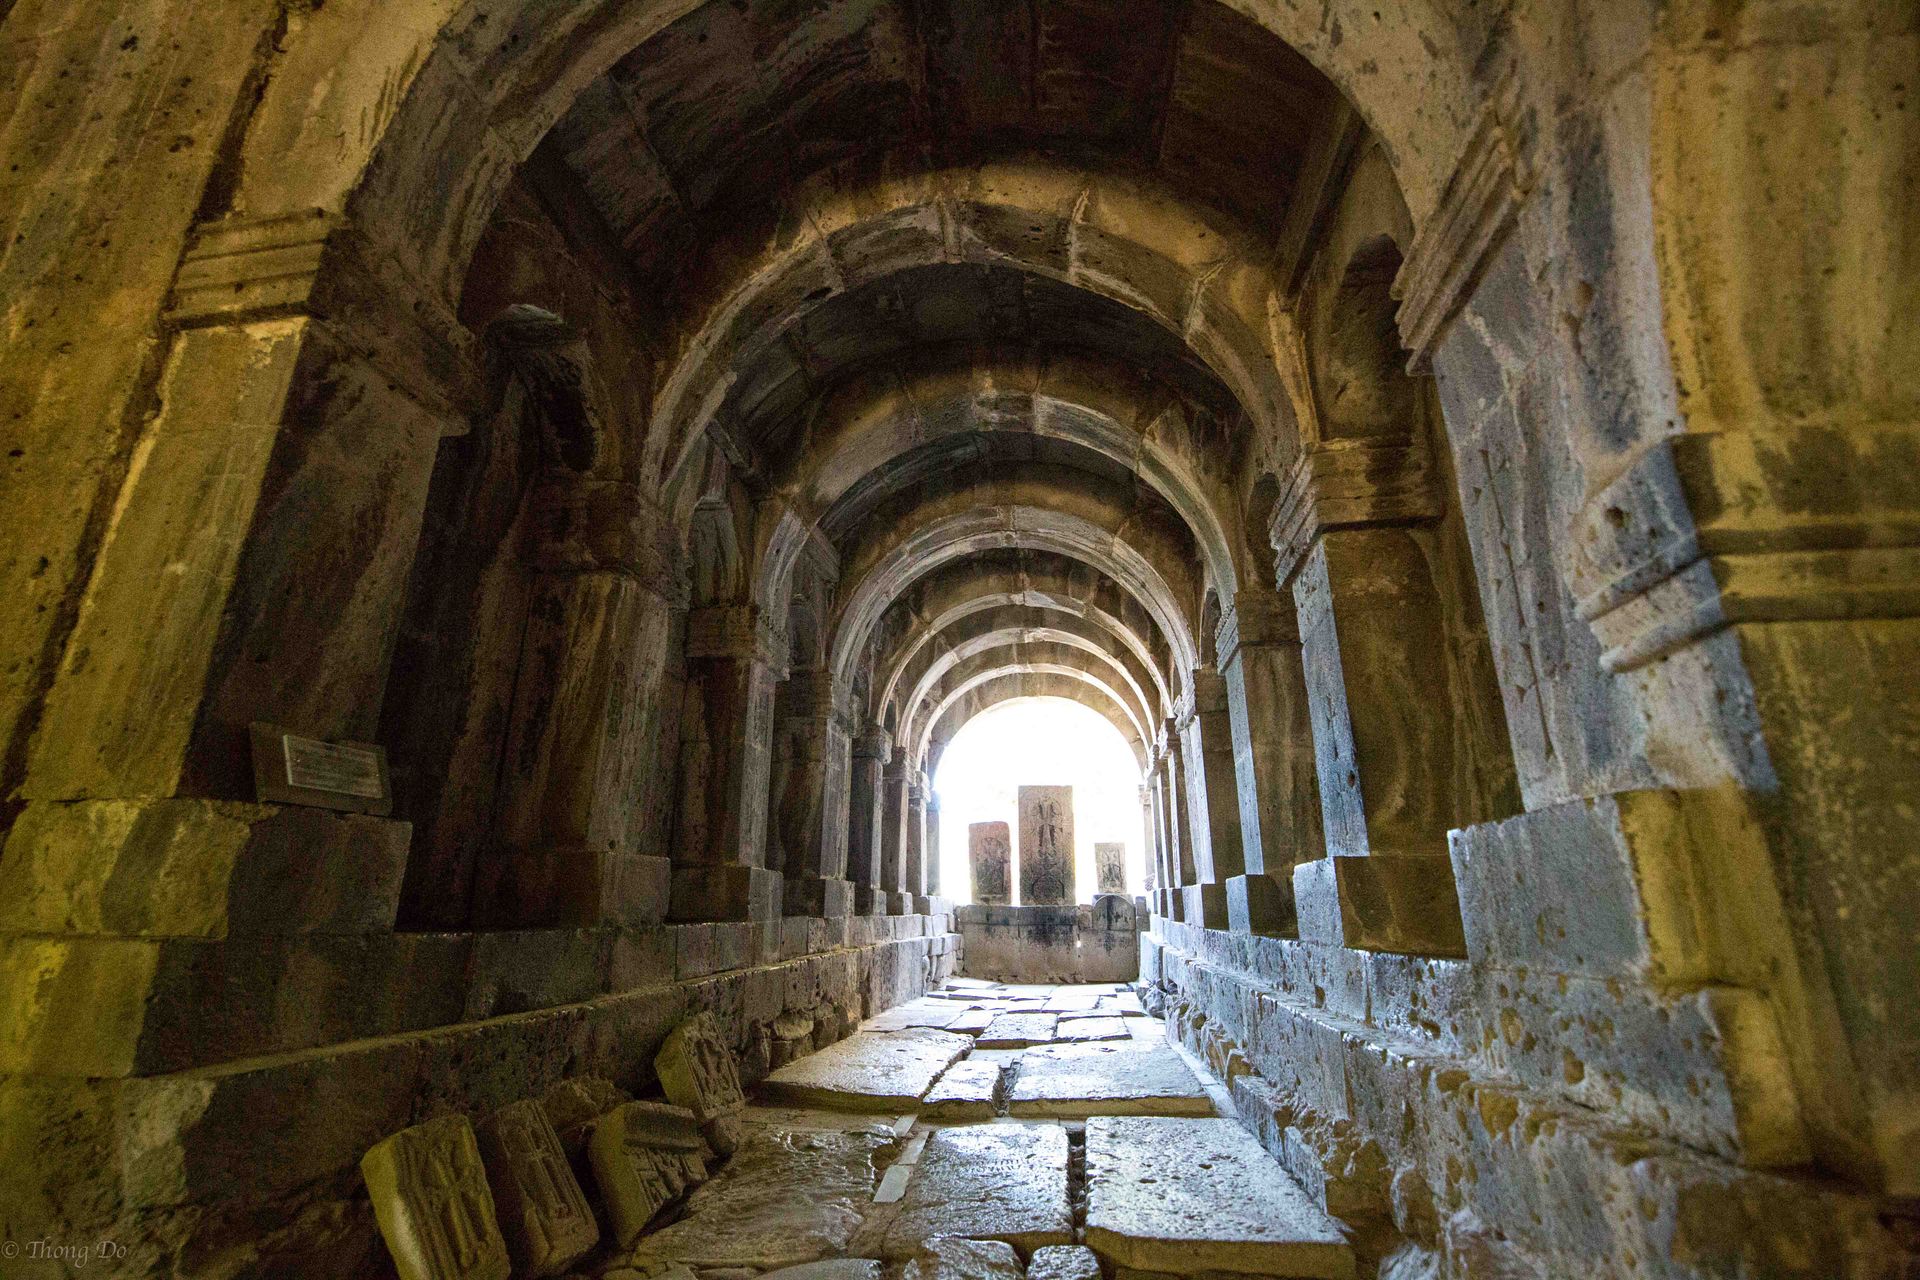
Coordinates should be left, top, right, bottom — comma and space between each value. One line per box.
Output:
1394, 73, 1534, 372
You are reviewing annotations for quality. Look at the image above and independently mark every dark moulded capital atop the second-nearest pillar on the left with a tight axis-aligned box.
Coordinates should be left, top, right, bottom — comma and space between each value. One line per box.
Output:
524, 472, 685, 608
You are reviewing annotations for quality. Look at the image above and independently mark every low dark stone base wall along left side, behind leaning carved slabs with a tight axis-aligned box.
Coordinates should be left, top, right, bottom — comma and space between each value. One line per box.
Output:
0, 890, 958, 1280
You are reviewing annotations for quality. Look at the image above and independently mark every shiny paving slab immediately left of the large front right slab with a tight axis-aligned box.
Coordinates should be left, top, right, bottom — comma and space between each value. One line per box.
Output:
858, 1125, 1073, 1259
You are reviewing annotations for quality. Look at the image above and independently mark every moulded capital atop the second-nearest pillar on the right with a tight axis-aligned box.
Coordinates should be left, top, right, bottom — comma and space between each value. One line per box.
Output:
1267, 436, 1442, 585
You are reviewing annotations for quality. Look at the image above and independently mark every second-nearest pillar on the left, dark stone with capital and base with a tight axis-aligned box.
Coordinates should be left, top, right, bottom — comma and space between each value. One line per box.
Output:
474, 474, 678, 927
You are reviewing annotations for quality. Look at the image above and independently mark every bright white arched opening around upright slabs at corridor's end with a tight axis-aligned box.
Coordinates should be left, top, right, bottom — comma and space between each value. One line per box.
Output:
933, 699, 1146, 904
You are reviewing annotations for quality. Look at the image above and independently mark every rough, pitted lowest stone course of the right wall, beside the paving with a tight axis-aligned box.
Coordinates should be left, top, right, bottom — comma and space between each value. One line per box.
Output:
1146, 931, 1897, 1280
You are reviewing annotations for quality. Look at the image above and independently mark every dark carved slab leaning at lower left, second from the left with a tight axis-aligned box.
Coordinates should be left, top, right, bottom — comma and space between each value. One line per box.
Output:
474, 1098, 599, 1276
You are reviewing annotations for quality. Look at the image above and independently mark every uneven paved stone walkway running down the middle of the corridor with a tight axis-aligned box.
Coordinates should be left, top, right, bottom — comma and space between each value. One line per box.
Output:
601, 979, 1354, 1280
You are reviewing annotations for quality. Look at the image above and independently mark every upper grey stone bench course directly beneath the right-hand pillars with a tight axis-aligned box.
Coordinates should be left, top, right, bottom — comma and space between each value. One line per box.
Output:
1140, 923, 1807, 1167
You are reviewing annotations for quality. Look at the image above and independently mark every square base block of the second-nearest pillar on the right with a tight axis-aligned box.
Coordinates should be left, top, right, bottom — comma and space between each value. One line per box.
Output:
1294, 854, 1467, 958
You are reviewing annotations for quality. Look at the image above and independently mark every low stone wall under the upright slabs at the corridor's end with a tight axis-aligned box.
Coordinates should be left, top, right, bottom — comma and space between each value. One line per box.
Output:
954, 894, 1146, 983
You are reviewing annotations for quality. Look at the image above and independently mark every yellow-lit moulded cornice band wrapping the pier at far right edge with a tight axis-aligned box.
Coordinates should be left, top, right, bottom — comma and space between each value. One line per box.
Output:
1572, 426, 1920, 672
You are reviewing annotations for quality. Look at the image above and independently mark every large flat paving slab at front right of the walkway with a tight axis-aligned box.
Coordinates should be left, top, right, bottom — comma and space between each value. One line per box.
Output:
1087, 1115, 1354, 1280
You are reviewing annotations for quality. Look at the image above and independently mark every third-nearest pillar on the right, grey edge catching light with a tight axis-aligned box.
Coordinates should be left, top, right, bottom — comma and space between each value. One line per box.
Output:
1217, 587, 1327, 936
